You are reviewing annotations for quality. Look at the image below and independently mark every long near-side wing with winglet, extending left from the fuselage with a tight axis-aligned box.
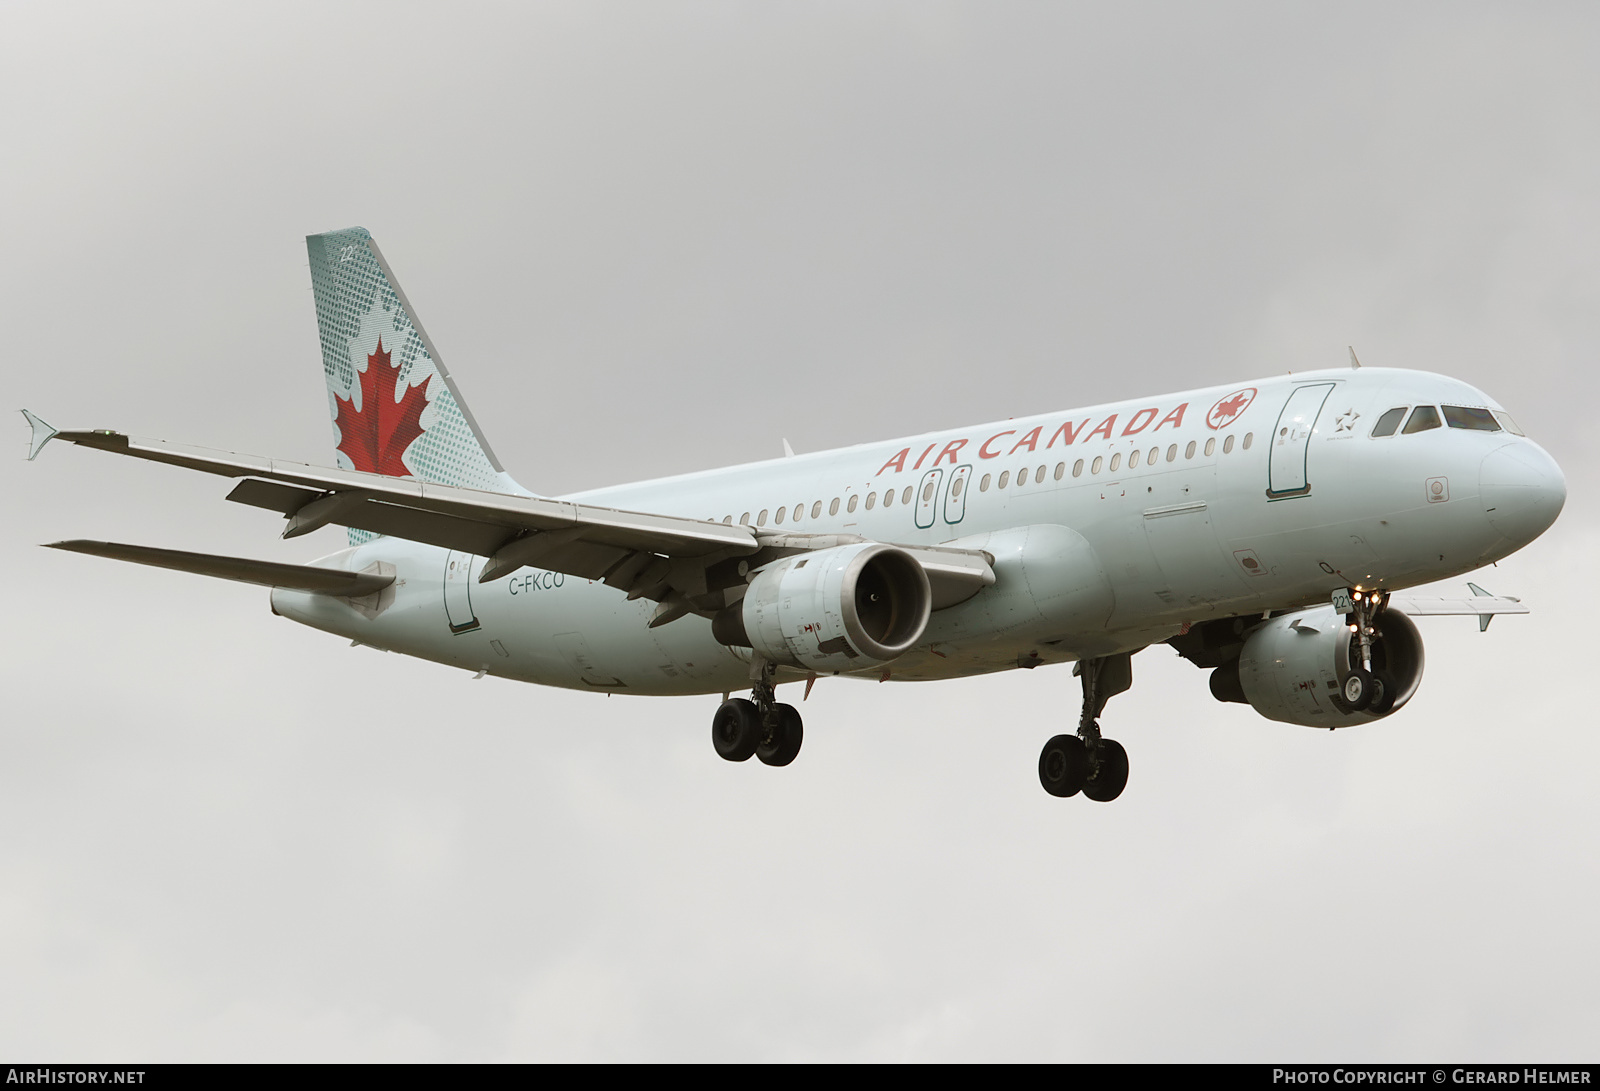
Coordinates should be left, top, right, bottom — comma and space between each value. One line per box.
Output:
27, 413, 995, 624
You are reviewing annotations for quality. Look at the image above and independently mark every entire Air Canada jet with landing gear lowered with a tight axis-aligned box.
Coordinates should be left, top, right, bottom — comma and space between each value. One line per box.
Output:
24, 227, 1566, 801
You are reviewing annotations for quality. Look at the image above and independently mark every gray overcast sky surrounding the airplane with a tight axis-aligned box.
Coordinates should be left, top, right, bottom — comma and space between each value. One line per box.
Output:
0, 3, 1600, 1061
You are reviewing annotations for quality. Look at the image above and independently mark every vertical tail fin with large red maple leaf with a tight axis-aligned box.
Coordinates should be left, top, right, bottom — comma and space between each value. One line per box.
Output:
306, 227, 528, 505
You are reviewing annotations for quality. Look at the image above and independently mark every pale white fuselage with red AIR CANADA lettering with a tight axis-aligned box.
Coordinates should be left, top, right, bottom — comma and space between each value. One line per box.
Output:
272, 368, 1565, 694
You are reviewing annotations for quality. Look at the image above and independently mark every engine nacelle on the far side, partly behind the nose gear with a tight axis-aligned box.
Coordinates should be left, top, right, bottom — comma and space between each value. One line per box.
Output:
1235, 606, 1422, 728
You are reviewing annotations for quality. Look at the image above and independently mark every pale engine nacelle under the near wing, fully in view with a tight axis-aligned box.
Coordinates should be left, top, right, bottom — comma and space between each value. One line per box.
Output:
712, 542, 933, 670
